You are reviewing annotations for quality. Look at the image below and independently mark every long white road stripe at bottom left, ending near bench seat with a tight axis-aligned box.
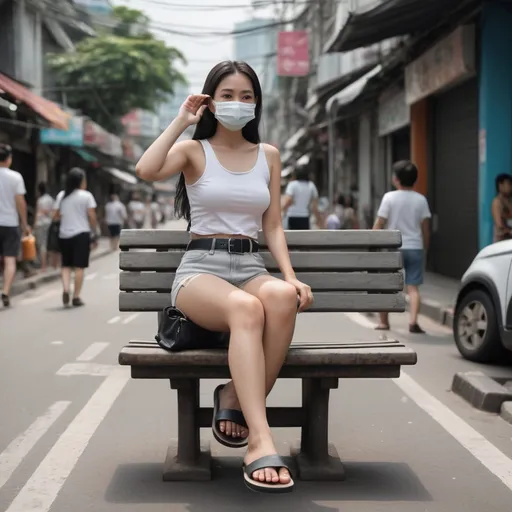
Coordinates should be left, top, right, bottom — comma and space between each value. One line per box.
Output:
6, 367, 130, 512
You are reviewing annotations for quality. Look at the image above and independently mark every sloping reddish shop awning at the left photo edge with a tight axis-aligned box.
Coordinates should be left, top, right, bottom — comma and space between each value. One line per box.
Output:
0, 73, 71, 130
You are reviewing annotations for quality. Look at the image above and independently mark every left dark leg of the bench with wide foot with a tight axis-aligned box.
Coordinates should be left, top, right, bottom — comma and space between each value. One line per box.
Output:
163, 379, 211, 482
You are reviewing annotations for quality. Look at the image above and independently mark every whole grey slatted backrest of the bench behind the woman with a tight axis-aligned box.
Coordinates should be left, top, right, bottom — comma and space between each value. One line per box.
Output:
119, 230, 405, 312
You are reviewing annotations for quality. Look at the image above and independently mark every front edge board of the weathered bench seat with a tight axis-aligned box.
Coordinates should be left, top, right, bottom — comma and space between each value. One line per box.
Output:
119, 345, 416, 368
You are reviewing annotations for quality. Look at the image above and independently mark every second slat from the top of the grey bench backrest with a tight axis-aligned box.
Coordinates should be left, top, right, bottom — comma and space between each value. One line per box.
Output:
119, 251, 402, 272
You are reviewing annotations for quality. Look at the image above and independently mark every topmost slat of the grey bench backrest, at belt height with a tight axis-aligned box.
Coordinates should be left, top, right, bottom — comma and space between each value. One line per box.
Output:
120, 229, 402, 250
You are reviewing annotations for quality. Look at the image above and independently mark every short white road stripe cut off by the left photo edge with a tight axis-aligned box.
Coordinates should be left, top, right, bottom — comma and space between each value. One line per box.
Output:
0, 402, 71, 489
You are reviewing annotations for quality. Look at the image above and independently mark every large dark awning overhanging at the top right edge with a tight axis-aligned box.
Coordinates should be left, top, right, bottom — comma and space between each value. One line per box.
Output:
329, 0, 468, 52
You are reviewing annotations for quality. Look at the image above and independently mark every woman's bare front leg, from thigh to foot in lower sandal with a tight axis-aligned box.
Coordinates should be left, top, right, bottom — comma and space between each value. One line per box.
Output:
176, 275, 290, 483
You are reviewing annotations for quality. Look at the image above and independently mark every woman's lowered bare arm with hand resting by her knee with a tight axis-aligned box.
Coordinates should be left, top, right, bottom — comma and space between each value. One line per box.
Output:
263, 144, 313, 312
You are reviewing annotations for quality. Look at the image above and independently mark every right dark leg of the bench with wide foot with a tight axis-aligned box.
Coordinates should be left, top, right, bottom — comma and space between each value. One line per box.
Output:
294, 378, 345, 481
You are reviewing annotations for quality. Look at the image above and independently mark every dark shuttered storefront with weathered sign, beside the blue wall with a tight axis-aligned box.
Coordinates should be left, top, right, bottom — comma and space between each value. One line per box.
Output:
405, 25, 479, 279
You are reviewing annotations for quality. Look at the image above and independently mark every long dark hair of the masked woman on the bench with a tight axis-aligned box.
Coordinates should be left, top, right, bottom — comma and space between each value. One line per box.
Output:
174, 60, 262, 222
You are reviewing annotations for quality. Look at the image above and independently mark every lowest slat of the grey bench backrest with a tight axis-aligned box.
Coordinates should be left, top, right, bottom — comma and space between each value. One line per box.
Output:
119, 292, 405, 313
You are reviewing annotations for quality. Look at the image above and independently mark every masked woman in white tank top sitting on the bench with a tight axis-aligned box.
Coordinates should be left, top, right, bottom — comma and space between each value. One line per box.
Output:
137, 61, 313, 492
